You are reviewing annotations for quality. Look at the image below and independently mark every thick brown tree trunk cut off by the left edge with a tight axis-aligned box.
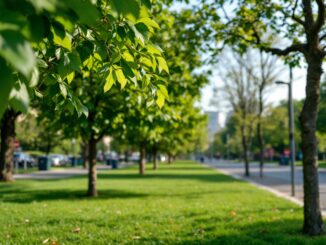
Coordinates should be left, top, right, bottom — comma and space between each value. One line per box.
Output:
0, 109, 18, 181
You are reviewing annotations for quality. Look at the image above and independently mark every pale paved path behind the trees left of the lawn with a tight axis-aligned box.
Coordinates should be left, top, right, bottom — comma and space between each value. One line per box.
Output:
14, 163, 133, 180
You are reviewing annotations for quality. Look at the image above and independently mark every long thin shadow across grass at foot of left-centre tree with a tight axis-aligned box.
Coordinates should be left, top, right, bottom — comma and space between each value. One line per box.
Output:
0, 189, 147, 203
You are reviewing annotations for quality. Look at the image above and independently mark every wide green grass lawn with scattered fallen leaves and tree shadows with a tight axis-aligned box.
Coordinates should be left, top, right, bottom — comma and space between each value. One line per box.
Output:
0, 162, 326, 245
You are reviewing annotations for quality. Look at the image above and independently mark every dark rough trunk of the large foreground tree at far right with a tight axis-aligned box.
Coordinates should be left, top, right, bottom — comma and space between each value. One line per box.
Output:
300, 53, 323, 236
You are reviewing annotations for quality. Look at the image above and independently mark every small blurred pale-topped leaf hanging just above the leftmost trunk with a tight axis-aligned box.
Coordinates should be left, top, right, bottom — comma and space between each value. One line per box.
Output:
9, 83, 29, 113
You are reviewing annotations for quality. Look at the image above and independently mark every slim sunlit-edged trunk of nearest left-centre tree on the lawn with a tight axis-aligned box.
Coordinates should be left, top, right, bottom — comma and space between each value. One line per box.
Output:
87, 135, 98, 197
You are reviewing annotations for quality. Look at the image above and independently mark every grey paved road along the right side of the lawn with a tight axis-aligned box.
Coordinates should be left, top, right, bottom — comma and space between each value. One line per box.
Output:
205, 161, 326, 211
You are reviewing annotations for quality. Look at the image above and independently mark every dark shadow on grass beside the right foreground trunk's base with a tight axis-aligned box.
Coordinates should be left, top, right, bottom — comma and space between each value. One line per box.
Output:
146, 219, 326, 245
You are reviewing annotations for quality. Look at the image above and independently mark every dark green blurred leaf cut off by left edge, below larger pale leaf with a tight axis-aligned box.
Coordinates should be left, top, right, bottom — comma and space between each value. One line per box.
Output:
0, 57, 15, 118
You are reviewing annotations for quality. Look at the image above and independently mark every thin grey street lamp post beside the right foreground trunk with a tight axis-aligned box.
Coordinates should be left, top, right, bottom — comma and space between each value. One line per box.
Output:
275, 66, 295, 196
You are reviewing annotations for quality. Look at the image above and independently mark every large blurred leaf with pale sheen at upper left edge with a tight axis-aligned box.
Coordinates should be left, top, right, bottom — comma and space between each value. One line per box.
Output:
0, 30, 36, 78
